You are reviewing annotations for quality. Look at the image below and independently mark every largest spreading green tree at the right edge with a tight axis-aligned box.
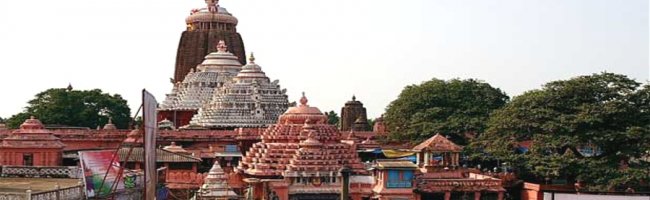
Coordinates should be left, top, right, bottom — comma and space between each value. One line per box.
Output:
475, 73, 650, 190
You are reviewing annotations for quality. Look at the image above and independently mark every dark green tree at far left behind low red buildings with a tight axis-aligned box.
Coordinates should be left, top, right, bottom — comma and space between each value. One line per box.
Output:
7, 88, 131, 128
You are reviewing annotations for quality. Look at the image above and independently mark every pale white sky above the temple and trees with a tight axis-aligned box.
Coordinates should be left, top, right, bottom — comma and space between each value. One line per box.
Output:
0, 0, 650, 118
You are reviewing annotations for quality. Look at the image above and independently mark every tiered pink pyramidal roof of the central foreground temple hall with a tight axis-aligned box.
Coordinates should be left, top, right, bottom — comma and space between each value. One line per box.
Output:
237, 96, 366, 177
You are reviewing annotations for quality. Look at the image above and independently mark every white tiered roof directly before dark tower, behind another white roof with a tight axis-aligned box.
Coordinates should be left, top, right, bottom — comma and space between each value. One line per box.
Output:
158, 40, 242, 127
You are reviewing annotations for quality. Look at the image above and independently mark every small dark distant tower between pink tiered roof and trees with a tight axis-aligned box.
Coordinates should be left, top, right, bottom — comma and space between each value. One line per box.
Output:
341, 96, 370, 131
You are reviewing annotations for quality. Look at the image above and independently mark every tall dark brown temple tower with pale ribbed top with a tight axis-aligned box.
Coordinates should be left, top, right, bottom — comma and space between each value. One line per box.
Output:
174, 0, 246, 82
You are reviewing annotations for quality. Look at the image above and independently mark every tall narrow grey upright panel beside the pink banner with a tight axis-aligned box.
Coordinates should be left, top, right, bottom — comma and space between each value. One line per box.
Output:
142, 90, 158, 200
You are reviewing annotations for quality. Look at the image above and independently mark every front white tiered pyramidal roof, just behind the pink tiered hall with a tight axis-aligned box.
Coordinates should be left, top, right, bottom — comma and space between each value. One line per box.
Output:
190, 54, 289, 129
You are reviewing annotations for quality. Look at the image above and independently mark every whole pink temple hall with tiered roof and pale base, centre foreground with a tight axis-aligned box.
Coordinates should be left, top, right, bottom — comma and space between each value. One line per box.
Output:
237, 94, 373, 200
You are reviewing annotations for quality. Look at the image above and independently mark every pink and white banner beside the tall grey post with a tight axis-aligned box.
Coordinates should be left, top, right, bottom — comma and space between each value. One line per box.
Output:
79, 150, 124, 197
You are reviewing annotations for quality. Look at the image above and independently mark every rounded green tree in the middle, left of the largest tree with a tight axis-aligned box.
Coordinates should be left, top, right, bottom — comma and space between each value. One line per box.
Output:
384, 79, 508, 145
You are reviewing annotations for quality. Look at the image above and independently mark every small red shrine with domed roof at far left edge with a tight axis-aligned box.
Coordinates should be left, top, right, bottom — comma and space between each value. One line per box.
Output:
0, 116, 65, 166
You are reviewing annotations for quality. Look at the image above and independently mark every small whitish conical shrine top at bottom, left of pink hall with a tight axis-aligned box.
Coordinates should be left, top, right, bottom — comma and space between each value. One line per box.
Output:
193, 162, 239, 200
